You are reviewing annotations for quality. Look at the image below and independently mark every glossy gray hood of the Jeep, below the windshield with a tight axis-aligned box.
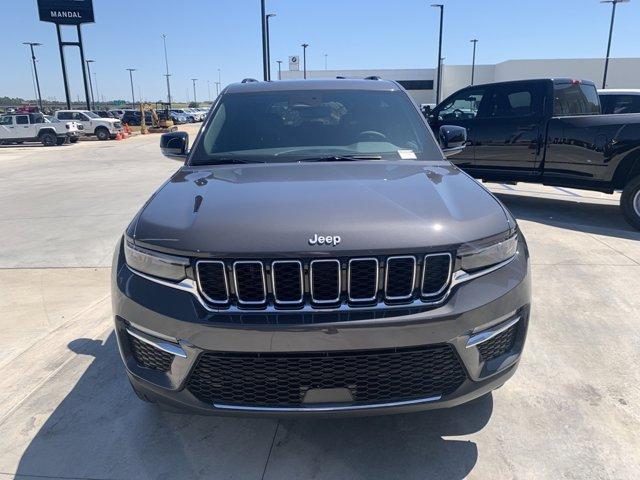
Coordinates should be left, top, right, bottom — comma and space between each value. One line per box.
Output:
127, 160, 513, 257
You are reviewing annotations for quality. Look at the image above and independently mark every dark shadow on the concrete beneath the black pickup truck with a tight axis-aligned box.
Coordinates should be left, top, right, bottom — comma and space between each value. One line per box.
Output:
494, 192, 640, 240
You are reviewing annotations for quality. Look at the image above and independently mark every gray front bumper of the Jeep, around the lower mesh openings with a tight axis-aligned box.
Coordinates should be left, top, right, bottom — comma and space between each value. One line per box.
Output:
112, 238, 530, 415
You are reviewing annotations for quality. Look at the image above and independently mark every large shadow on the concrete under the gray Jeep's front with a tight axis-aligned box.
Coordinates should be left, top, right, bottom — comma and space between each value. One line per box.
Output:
12, 333, 493, 480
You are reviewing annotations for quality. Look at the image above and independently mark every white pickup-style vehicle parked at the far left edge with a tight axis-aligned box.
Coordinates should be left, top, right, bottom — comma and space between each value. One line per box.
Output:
0, 113, 77, 147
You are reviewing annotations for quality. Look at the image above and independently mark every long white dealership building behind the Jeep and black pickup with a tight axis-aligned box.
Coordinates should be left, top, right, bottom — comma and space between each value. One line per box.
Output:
281, 58, 640, 103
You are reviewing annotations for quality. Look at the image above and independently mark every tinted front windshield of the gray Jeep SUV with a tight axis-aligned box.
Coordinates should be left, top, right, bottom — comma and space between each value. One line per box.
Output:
190, 90, 442, 165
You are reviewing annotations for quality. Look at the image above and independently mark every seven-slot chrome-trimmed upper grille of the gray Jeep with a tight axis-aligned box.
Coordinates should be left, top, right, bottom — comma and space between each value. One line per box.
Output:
196, 253, 454, 310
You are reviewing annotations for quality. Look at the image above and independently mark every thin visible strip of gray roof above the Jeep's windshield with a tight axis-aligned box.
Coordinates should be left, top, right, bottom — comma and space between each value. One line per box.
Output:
225, 78, 401, 93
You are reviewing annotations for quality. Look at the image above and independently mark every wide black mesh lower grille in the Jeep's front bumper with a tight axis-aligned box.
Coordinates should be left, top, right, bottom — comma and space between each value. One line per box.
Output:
187, 345, 466, 407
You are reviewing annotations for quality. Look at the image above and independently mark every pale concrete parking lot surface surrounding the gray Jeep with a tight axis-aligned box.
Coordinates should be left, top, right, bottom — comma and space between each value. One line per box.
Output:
0, 126, 640, 480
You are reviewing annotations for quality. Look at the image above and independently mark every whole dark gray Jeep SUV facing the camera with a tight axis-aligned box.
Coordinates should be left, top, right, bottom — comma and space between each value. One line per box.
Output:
112, 79, 530, 415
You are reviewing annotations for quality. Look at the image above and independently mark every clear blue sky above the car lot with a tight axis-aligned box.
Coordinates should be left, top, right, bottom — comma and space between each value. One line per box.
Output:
0, 0, 640, 101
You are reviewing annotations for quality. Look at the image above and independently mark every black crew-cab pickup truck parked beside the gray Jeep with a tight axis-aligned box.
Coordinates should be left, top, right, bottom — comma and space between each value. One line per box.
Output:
427, 78, 640, 229
